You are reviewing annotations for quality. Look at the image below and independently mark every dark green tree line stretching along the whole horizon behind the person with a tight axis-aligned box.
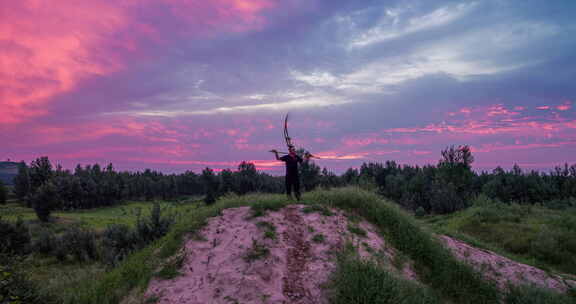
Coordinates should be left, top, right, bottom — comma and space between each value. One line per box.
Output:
0, 146, 576, 220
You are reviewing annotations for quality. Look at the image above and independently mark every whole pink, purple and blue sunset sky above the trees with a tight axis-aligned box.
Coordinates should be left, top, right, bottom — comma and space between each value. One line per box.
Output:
0, 0, 576, 174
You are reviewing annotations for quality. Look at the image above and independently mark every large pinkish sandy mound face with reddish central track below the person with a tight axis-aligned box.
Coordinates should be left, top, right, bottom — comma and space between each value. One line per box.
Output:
146, 205, 413, 304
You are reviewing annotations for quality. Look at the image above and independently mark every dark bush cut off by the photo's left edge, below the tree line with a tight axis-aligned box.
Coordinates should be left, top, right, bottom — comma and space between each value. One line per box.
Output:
0, 217, 30, 254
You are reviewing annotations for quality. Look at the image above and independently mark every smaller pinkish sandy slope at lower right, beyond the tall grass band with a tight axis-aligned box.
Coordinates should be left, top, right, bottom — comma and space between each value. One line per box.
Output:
440, 235, 576, 292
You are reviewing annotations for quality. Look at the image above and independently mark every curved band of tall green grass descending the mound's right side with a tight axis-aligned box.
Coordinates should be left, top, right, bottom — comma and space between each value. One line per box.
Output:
304, 188, 498, 303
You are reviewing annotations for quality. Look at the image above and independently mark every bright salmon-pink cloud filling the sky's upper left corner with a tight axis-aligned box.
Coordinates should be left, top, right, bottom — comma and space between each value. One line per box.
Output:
0, 0, 276, 124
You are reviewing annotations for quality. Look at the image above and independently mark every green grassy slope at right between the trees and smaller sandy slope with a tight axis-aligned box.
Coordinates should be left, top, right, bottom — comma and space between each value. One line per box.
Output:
421, 198, 576, 275
